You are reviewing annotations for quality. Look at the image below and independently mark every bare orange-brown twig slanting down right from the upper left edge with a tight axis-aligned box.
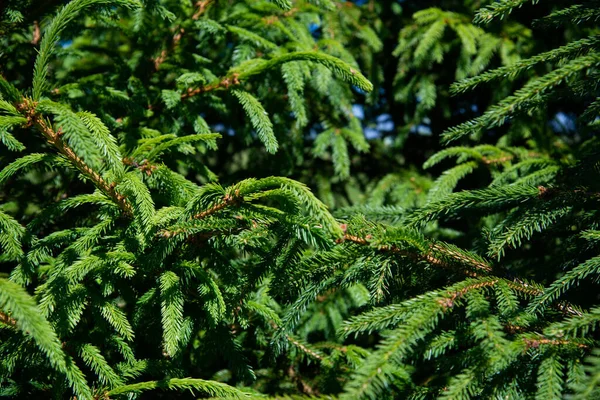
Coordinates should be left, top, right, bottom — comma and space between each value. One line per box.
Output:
17, 99, 132, 216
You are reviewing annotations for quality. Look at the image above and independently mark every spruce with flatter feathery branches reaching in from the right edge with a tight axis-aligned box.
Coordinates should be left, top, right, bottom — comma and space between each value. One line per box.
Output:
280, 0, 600, 399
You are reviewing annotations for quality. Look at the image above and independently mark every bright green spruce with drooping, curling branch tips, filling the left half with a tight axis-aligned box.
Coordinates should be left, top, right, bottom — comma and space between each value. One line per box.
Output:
0, 0, 373, 399
